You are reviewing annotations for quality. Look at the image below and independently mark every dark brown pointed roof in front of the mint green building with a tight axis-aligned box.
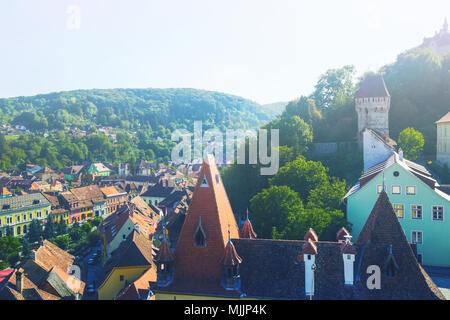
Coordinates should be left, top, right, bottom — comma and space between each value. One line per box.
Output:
356, 191, 444, 299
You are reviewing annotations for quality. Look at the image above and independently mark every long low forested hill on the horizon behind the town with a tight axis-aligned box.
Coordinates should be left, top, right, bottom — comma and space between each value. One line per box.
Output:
0, 89, 275, 131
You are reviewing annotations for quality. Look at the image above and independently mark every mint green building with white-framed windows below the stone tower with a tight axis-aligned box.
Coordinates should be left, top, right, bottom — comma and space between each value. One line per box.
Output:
344, 152, 450, 267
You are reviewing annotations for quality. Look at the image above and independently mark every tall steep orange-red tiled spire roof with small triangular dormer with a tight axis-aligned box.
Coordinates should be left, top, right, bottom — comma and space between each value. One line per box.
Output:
174, 155, 243, 286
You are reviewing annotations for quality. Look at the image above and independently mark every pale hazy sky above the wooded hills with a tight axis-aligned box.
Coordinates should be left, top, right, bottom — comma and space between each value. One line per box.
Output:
0, 0, 450, 103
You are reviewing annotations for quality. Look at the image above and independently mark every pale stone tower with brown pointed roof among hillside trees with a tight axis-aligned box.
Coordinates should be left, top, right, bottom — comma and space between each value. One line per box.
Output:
355, 75, 391, 142
